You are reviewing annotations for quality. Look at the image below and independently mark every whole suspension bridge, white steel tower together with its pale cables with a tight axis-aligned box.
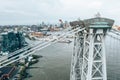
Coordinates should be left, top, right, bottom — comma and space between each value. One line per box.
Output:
0, 17, 120, 80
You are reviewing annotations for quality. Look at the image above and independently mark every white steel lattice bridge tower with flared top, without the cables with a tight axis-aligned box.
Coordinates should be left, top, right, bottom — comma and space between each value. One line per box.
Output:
70, 17, 114, 80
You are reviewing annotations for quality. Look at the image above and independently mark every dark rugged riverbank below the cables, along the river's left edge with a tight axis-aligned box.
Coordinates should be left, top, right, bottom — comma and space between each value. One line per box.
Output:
13, 55, 42, 80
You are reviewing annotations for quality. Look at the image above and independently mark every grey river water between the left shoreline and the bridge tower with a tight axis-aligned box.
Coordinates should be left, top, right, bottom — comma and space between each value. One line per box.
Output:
26, 43, 73, 80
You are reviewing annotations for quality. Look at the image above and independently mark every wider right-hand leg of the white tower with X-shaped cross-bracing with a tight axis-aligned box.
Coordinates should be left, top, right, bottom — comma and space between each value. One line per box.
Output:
81, 29, 107, 80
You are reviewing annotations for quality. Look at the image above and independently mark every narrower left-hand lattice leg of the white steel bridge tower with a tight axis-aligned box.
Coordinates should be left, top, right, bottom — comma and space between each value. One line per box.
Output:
70, 25, 84, 80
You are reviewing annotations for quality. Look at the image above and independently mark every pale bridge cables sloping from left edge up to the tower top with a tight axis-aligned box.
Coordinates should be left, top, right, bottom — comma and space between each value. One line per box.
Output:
0, 27, 85, 68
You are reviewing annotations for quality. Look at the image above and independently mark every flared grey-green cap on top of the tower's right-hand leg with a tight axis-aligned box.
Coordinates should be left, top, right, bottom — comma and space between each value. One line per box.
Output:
83, 17, 114, 29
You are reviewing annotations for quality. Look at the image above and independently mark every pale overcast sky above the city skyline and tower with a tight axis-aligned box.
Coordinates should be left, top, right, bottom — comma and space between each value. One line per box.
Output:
0, 0, 120, 25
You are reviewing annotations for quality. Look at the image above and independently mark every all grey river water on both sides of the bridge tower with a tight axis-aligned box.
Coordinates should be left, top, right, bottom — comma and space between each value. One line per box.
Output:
26, 32, 120, 80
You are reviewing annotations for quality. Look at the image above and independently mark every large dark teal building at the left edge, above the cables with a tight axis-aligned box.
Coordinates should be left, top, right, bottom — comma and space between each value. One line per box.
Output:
0, 31, 27, 54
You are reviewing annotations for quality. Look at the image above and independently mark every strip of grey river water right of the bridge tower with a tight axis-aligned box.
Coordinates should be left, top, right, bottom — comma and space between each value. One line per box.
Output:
106, 34, 120, 80
